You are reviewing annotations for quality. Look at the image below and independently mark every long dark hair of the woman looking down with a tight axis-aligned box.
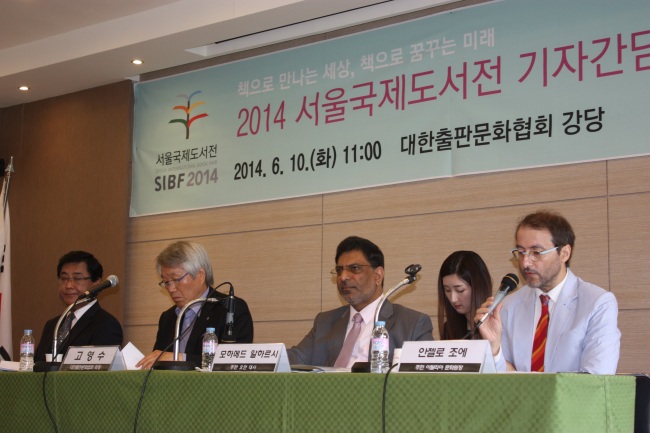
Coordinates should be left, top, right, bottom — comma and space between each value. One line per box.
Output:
438, 251, 492, 340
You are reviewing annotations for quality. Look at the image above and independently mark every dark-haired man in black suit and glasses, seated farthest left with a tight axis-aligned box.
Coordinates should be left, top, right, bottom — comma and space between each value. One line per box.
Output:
34, 251, 122, 361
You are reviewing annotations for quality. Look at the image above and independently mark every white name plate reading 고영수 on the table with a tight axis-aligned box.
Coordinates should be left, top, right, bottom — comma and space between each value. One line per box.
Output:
59, 346, 124, 371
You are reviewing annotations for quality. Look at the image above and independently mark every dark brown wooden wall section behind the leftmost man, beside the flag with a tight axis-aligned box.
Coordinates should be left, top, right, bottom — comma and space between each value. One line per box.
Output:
0, 81, 133, 354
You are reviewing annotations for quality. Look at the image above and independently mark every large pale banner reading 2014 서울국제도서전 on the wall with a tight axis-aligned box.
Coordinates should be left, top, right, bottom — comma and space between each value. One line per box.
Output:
130, 0, 650, 216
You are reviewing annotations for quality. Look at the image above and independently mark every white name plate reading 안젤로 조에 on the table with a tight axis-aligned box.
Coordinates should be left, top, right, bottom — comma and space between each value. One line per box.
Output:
399, 340, 496, 373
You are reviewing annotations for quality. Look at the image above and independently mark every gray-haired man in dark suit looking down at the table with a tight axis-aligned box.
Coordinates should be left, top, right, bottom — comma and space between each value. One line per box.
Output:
136, 241, 253, 369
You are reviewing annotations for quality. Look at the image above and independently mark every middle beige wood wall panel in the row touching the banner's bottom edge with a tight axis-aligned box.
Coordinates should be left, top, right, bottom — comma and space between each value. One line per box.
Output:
323, 162, 607, 224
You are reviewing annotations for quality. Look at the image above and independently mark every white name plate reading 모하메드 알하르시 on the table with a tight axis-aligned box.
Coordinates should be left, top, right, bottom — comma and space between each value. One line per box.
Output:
212, 343, 291, 373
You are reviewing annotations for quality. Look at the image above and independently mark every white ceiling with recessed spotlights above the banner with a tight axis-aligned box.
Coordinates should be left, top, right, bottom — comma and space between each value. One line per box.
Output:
0, 0, 450, 108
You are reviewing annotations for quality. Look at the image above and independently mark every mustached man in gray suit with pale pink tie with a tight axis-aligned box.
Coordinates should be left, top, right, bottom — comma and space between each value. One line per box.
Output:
288, 236, 433, 368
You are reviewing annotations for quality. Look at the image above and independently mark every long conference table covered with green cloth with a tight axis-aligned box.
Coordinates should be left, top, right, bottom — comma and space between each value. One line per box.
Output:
0, 370, 635, 433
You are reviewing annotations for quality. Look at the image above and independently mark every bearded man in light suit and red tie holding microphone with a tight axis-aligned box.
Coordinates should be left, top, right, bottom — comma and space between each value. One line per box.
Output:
476, 211, 621, 374
